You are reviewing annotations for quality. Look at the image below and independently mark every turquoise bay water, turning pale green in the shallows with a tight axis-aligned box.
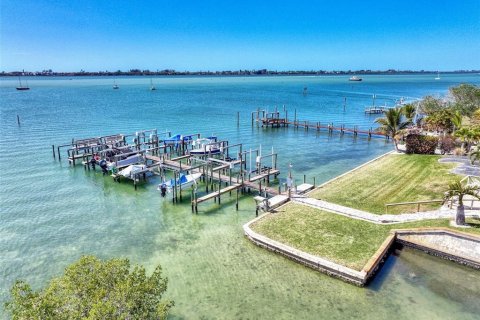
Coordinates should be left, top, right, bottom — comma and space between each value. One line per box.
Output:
0, 75, 480, 319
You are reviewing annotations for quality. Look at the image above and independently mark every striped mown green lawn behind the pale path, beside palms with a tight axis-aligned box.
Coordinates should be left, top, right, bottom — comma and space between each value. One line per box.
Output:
309, 154, 460, 214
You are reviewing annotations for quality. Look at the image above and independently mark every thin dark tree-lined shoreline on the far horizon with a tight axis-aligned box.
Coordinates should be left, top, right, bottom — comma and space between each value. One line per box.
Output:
0, 69, 480, 77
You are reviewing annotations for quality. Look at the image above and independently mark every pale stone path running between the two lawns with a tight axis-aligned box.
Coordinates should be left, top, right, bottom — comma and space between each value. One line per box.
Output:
293, 197, 480, 224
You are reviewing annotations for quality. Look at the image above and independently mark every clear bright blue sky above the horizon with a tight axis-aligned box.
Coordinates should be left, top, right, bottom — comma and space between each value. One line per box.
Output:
0, 0, 480, 71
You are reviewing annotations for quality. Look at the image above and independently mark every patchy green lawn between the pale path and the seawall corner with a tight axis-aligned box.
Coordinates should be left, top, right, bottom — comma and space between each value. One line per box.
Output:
251, 203, 480, 270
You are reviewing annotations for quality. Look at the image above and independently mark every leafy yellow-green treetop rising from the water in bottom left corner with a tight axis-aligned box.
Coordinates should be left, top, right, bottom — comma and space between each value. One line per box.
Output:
5, 256, 173, 319
